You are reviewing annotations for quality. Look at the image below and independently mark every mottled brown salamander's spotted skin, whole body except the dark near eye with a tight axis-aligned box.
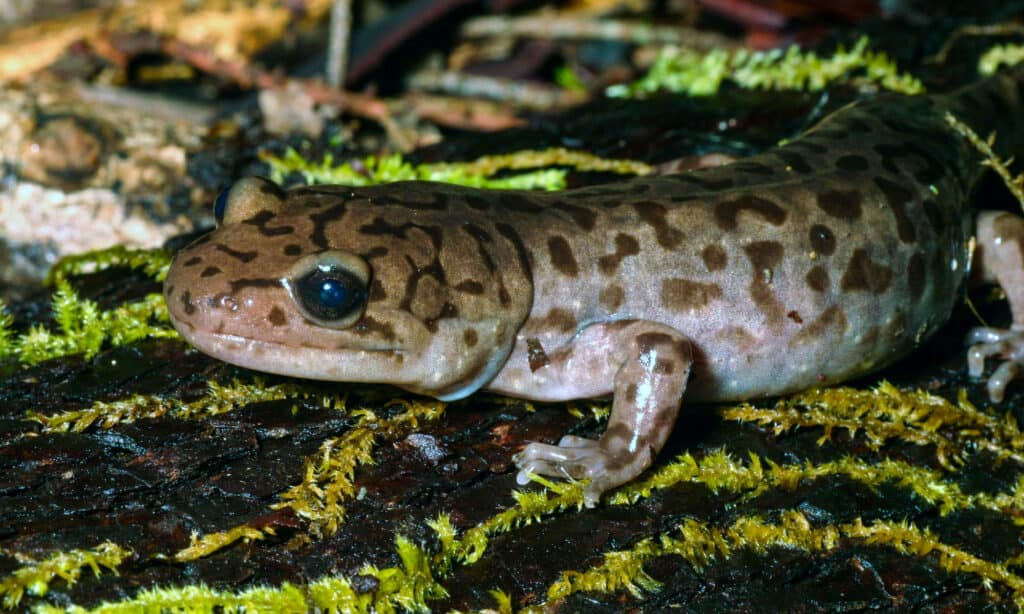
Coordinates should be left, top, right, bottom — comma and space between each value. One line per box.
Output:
165, 64, 1024, 505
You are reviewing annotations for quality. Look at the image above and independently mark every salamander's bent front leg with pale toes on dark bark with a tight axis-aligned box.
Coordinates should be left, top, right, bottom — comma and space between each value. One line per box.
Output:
515, 320, 692, 507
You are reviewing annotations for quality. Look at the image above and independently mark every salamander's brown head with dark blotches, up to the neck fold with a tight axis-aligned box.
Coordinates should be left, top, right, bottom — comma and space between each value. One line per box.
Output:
164, 178, 518, 398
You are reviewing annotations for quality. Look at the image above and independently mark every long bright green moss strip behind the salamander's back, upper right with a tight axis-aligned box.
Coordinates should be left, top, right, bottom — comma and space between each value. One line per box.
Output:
606, 37, 925, 97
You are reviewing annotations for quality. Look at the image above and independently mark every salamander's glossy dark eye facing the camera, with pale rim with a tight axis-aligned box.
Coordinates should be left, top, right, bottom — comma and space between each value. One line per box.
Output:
282, 250, 370, 328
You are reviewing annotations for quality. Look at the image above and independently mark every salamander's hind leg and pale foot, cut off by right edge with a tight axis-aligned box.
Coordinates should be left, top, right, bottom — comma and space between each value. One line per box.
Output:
967, 211, 1024, 401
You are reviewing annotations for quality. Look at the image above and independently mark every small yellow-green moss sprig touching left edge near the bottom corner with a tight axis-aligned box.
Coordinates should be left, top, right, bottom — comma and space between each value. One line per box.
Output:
0, 541, 134, 609
